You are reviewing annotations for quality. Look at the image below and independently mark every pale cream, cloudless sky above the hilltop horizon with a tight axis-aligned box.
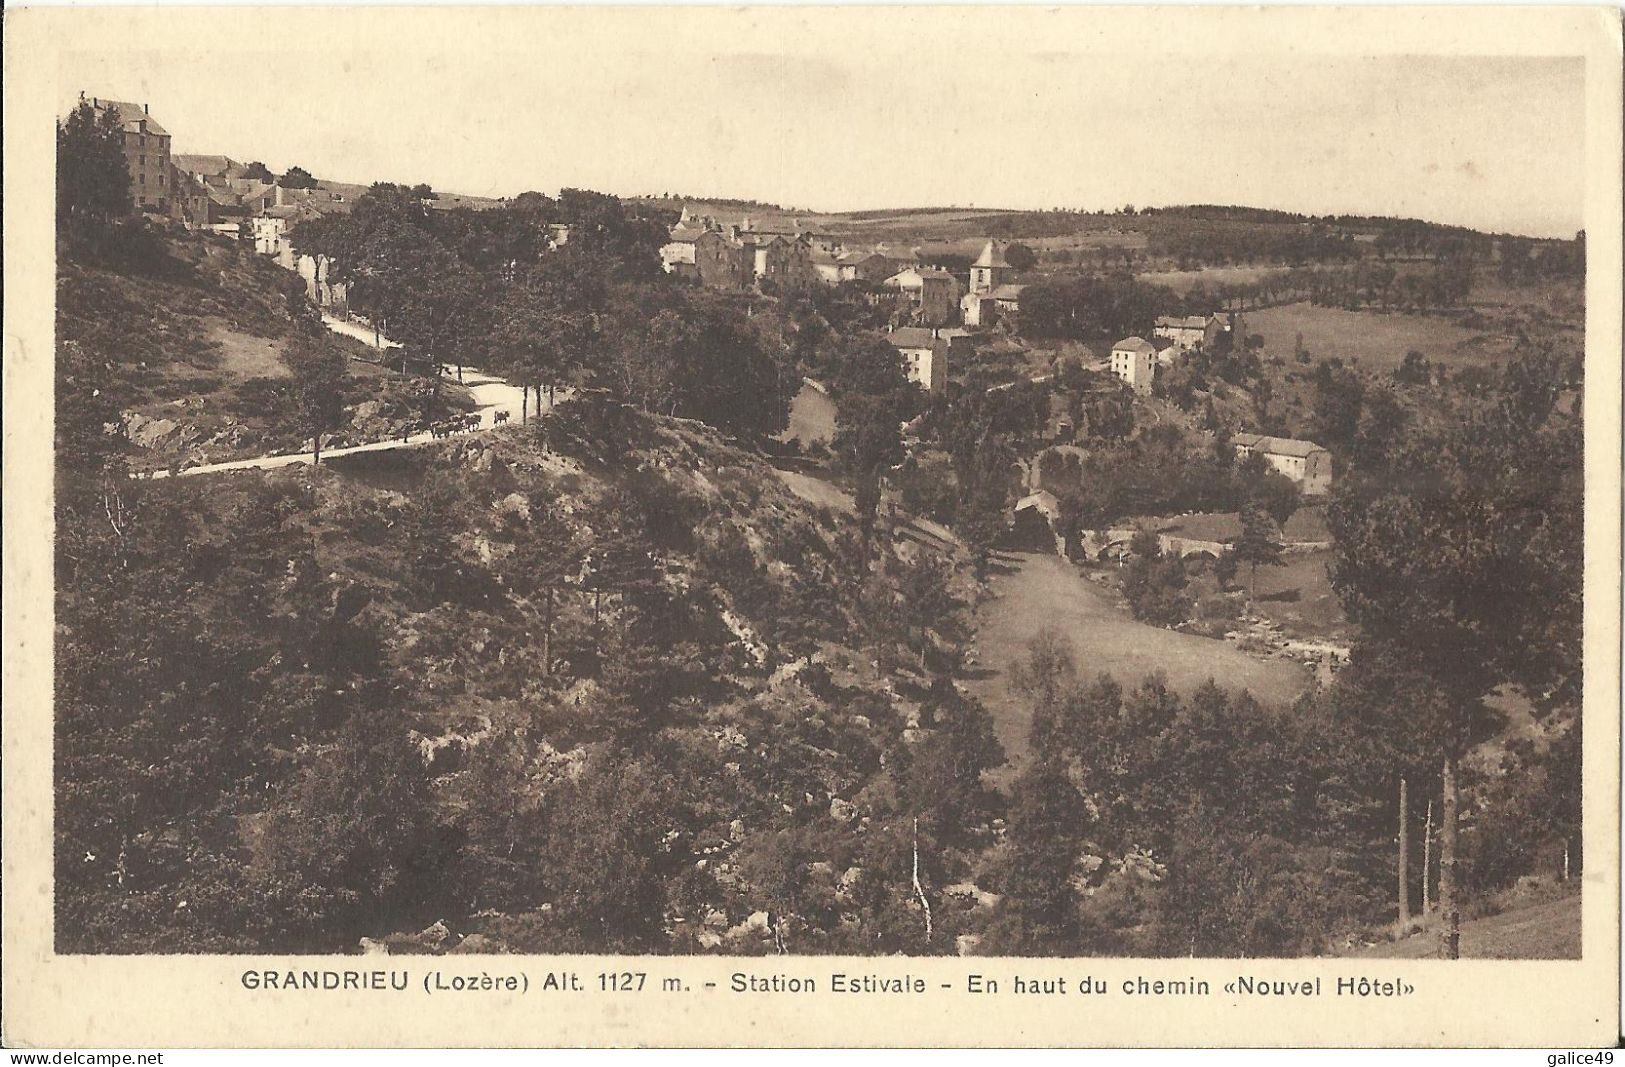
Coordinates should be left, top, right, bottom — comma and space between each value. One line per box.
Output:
59, 10, 1584, 237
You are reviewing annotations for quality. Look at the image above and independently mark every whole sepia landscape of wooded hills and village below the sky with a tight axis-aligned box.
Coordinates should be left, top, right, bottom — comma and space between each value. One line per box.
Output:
57, 96, 1584, 957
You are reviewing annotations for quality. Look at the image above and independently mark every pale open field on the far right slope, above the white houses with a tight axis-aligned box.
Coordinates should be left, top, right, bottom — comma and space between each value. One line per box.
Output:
1246, 300, 1510, 370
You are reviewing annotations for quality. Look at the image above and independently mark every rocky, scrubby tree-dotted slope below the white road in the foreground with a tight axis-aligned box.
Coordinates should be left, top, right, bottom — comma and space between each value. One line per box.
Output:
57, 400, 998, 952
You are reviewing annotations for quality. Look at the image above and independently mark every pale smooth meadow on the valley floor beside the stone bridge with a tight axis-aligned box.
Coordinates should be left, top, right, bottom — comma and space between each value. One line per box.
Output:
967, 554, 1310, 776
